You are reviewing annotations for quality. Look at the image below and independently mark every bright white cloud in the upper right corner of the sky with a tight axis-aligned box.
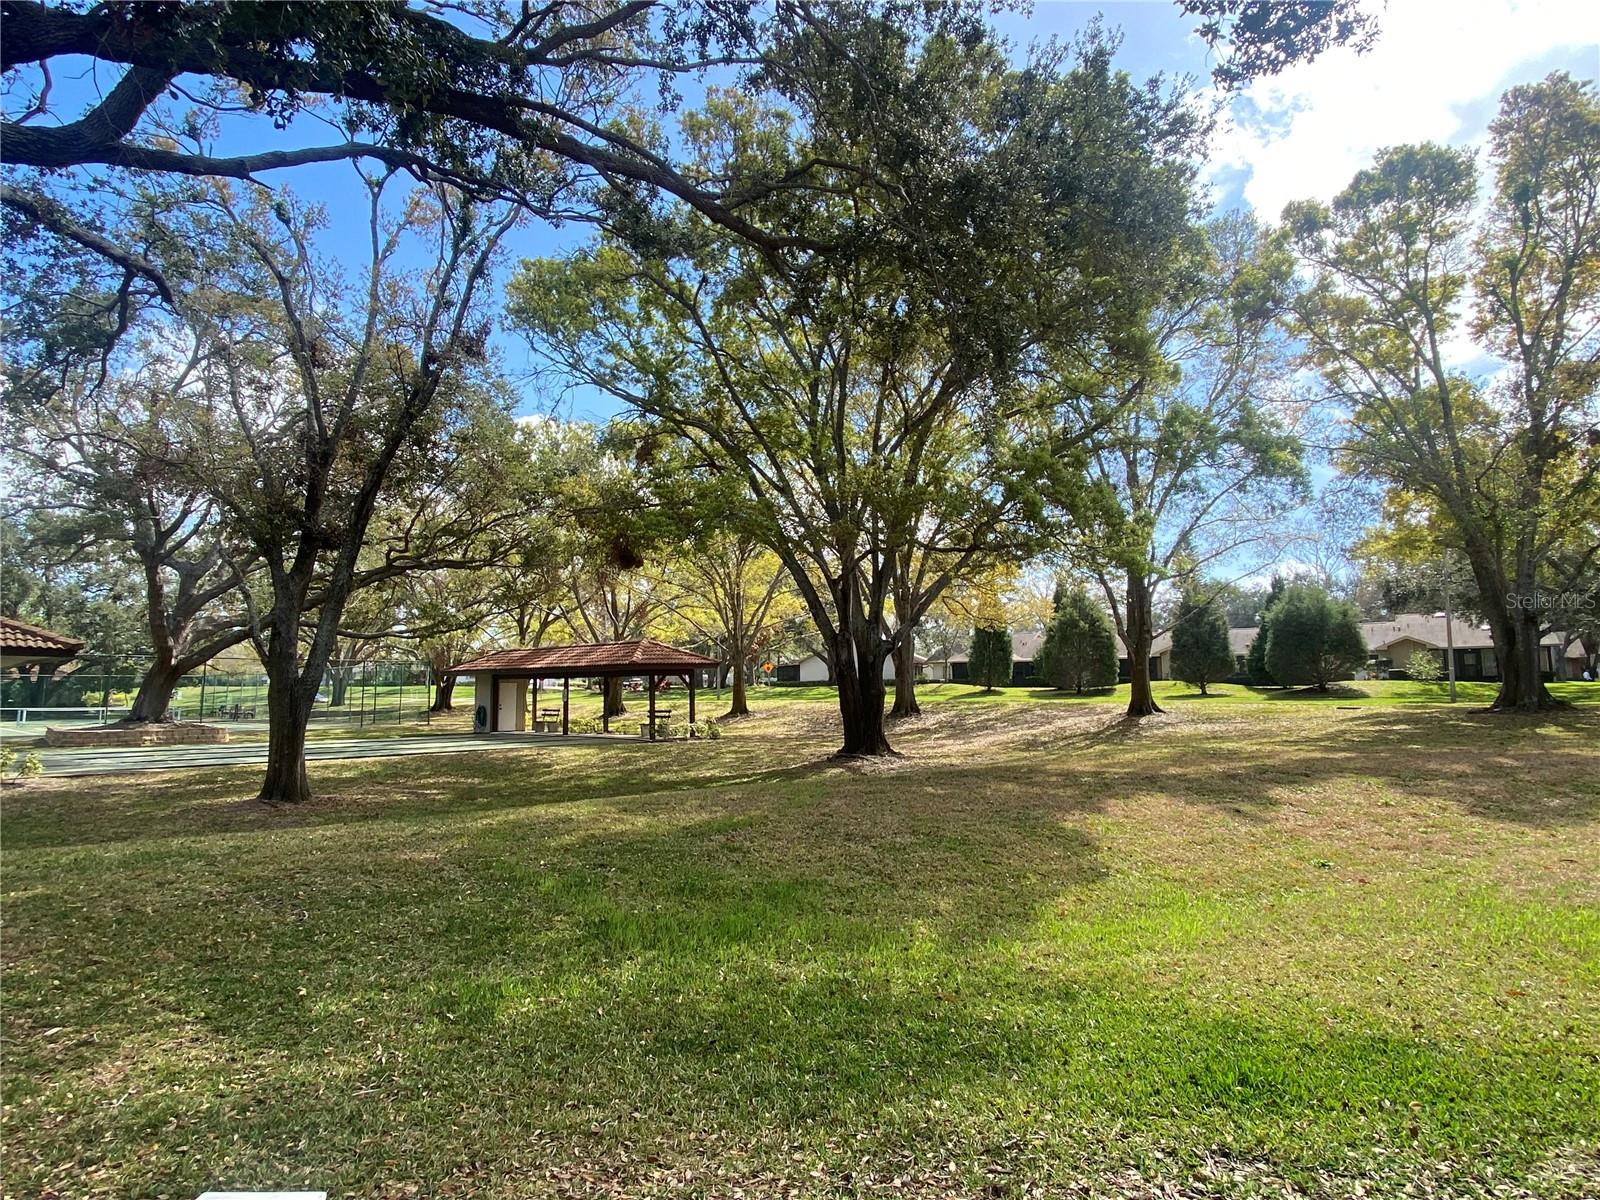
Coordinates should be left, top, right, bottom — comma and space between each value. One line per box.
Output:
1210, 0, 1600, 221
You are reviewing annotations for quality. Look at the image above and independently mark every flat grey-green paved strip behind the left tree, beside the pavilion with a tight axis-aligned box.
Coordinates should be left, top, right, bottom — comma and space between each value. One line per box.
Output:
38, 733, 648, 776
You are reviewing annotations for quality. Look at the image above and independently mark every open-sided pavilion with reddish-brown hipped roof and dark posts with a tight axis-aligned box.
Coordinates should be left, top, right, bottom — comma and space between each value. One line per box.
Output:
450, 637, 718, 741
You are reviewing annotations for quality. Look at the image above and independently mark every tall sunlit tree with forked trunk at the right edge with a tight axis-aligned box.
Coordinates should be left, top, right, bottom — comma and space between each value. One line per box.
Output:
1285, 72, 1600, 710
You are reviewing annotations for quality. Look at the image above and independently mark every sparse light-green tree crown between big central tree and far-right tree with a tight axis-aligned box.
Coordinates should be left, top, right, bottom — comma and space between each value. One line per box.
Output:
1053, 214, 1307, 675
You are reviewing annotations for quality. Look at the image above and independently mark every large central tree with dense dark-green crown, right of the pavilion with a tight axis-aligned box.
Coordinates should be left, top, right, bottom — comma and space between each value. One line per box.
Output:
509, 25, 1198, 754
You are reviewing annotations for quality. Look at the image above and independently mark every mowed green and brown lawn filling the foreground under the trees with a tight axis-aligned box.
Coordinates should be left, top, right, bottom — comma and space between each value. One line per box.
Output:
3, 696, 1600, 1200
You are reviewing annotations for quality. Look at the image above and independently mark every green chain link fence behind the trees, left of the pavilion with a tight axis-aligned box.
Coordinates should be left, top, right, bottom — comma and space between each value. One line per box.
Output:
0, 654, 434, 731
